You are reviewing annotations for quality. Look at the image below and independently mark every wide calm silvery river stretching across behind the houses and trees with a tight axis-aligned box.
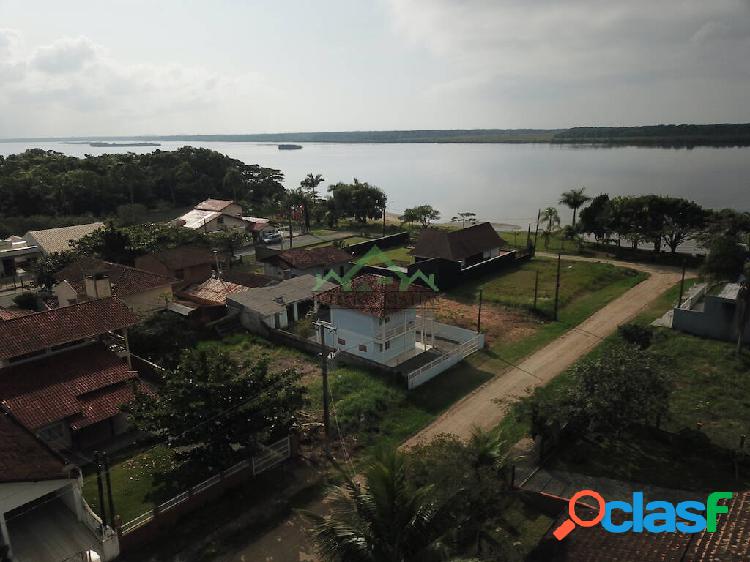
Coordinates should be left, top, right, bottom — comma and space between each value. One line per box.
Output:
0, 141, 750, 226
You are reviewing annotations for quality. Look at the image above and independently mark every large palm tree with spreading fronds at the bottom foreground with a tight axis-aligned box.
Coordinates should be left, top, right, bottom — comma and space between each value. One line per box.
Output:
304, 450, 448, 562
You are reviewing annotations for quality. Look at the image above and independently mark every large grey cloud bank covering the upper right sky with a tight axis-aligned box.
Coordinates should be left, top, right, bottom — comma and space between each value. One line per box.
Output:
389, 0, 750, 126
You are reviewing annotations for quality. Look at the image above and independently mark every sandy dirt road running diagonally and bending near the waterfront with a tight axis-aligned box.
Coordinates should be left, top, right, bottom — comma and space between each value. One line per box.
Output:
403, 252, 692, 448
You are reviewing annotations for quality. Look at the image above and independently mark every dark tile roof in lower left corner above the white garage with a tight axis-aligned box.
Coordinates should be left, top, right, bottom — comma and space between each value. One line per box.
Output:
0, 408, 68, 483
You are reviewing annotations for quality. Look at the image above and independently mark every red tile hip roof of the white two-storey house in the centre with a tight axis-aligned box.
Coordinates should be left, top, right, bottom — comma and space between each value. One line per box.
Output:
315, 275, 436, 318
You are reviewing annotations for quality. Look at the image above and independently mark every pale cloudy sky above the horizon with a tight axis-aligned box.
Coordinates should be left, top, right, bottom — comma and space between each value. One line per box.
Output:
0, 0, 750, 138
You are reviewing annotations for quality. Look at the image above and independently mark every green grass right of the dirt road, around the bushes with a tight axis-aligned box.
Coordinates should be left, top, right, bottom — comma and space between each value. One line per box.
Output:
496, 281, 750, 490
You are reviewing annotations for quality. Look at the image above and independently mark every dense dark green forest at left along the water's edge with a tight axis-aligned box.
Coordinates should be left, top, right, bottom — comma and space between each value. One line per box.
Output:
0, 147, 284, 235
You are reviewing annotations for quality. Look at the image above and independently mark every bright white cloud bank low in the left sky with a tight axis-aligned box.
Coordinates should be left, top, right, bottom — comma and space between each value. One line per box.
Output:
0, 30, 282, 137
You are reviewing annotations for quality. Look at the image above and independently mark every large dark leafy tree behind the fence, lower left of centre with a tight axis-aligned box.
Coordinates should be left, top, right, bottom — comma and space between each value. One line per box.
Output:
128, 349, 306, 468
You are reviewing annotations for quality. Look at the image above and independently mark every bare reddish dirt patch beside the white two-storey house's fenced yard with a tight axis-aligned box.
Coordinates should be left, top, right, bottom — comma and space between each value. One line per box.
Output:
435, 297, 542, 346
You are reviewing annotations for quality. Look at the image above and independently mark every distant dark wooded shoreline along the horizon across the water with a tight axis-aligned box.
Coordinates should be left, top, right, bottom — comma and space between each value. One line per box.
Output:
10, 123, 750, 150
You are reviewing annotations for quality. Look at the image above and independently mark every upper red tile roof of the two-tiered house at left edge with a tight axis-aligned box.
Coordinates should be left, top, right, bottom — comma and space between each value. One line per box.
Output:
0, 297, 138, 359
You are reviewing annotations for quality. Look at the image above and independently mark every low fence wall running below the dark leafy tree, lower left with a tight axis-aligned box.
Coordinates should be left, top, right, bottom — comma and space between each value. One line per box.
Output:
121, 436, 292, 535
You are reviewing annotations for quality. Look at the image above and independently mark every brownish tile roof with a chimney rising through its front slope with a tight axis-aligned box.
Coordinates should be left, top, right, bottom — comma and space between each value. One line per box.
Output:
55, 257, 176, 297
